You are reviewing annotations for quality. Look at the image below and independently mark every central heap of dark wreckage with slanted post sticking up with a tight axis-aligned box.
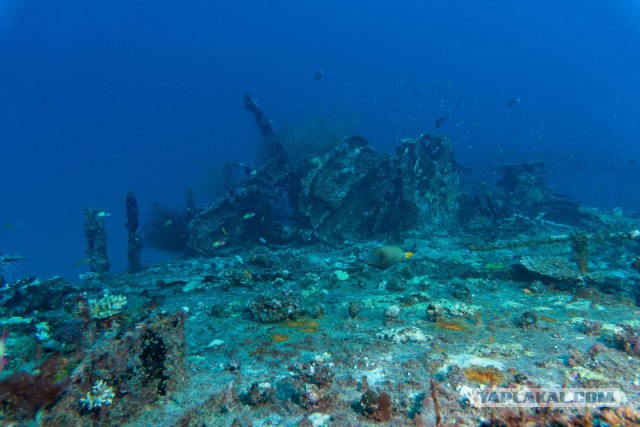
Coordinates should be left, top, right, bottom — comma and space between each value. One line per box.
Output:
188, 95, 458, 255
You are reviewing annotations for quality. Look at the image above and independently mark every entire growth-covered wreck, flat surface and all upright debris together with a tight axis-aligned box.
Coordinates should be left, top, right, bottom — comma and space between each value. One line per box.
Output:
0, 94, 640, 426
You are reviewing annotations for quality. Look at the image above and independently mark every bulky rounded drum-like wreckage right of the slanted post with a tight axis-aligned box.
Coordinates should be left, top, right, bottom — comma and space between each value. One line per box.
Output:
296, 134, 458, 243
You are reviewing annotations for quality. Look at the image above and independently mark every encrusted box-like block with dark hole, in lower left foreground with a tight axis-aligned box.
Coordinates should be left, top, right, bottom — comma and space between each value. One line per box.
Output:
39, 310, 186, 425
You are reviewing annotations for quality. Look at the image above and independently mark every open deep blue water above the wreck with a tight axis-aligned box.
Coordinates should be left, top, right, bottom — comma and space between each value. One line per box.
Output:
0, 0, 640, 278
